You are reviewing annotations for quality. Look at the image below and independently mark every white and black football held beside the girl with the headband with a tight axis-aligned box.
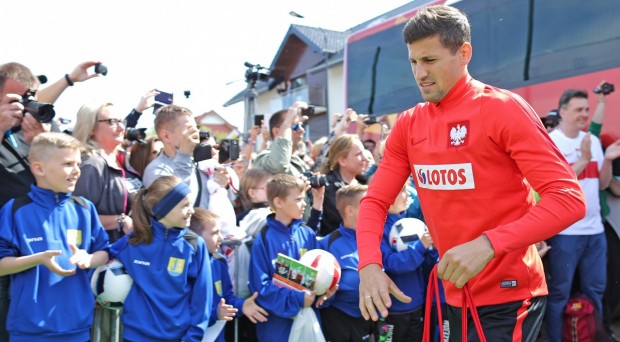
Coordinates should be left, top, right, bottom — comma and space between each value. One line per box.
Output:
90, 260, 133, 308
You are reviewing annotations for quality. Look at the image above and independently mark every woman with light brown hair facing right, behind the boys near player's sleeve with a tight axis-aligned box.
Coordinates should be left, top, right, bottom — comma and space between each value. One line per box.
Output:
317, 134, 368, 236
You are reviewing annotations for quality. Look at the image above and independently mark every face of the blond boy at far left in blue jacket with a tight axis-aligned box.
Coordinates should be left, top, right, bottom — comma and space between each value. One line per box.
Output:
32, 148, 82, 193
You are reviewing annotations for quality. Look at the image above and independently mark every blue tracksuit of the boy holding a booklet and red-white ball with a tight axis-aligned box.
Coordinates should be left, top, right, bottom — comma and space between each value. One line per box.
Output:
249, 214, 318, 342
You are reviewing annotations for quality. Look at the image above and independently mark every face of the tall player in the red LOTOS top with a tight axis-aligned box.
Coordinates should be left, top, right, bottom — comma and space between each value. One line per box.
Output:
407, 35, 471, 102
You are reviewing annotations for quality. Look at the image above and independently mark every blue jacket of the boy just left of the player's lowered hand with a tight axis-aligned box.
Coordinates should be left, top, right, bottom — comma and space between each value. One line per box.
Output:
319, 224, 362, 318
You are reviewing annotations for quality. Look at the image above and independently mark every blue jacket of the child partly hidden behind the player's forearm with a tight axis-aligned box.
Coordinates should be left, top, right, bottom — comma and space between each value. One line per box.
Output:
381, 214, 438, 313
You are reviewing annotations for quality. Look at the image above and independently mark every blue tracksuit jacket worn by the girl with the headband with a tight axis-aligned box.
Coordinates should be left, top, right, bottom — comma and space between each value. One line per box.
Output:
110, 218, 213, 342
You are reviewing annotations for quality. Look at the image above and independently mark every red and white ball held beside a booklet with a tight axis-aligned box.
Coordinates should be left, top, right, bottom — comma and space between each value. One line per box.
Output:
299, 249, 341, 295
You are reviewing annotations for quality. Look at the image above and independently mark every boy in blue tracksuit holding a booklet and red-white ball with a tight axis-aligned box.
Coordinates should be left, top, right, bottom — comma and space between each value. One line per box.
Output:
249, 174, 324, 342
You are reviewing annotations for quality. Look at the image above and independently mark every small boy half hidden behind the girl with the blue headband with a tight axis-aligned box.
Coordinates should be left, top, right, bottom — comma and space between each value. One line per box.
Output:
189, 208, 269, 342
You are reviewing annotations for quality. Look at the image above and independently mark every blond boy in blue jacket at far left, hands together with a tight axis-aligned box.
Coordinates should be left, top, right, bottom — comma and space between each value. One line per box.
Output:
0, 133, 108, 342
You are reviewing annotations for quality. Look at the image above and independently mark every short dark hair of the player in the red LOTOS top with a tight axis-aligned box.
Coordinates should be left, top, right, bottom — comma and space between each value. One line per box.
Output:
403, 5, 471, 54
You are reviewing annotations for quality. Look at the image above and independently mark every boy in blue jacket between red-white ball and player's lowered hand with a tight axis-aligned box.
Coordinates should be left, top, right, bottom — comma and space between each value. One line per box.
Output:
319, 184, 373, 342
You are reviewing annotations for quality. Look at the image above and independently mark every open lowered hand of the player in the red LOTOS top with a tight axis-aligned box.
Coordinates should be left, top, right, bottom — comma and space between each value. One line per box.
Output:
359, 264, 411, 321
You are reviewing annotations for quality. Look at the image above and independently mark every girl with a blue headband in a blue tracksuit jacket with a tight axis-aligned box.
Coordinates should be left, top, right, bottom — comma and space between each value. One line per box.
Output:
110, 176, 213, 342
